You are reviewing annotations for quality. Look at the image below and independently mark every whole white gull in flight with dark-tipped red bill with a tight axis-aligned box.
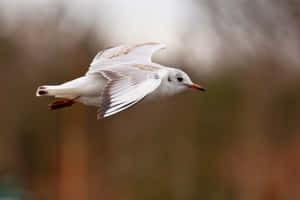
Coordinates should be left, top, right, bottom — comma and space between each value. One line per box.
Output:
36, 42, 205, 119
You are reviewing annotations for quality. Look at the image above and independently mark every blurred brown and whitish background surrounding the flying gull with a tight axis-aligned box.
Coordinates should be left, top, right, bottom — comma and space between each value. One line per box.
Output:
0, 0, 300, 200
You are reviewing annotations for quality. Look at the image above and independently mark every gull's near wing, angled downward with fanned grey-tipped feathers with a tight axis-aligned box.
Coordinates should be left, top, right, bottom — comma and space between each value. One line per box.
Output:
97, 65, 161, 119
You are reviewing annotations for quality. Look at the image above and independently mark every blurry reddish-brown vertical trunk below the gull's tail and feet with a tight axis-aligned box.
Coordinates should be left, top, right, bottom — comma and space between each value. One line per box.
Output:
59, 108, 88, 200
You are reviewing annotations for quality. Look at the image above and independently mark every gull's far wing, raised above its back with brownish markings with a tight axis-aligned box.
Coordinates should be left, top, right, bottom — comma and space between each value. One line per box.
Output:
88, 42, 165, 73
